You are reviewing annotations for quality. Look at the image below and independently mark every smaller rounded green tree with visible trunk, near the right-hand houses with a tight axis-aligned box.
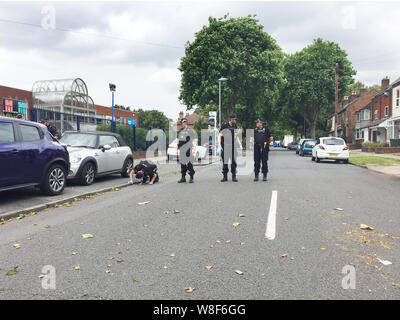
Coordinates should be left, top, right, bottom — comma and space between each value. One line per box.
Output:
285, 38, 356, 139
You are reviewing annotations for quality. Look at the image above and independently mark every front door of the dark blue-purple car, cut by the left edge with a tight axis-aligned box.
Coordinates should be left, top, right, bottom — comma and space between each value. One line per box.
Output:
0, 121, 23, 188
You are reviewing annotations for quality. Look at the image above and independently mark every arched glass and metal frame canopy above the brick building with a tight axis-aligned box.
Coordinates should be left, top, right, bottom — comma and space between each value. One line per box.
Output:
32, 78, 96, 114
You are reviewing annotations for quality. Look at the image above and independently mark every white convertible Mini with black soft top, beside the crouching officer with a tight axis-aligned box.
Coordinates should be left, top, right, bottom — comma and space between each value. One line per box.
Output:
60, 131, 133, 185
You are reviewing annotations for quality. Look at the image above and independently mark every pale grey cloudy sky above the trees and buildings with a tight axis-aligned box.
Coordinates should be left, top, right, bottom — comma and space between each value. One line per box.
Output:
0, 1, 400, 118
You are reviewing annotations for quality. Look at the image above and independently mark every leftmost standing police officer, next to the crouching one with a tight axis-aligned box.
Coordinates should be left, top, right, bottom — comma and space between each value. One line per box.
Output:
178, 118, 197, 183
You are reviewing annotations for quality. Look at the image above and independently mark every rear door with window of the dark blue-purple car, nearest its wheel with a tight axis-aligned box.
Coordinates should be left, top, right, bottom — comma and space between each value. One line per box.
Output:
16, 123, 47, 183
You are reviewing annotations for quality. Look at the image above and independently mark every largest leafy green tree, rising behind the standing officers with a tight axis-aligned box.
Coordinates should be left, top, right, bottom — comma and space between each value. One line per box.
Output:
179, 15, 283, 127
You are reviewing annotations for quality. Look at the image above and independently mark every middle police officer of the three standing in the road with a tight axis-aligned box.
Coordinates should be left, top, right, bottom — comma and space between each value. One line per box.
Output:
218, 115, 243, 182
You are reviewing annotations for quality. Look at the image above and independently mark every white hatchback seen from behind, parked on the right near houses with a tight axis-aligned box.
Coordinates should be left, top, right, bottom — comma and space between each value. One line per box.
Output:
311, 137, 349, 163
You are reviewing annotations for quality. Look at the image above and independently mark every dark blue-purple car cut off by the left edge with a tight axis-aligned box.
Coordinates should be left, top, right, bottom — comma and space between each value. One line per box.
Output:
0, 117, 70, 196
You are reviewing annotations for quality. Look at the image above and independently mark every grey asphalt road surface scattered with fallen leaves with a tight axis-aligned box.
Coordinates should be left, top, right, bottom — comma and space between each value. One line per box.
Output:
0, 152, 400, 299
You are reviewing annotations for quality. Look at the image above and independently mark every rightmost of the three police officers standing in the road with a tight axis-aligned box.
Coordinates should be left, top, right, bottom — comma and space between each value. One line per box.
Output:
254, 118, 272, 181
